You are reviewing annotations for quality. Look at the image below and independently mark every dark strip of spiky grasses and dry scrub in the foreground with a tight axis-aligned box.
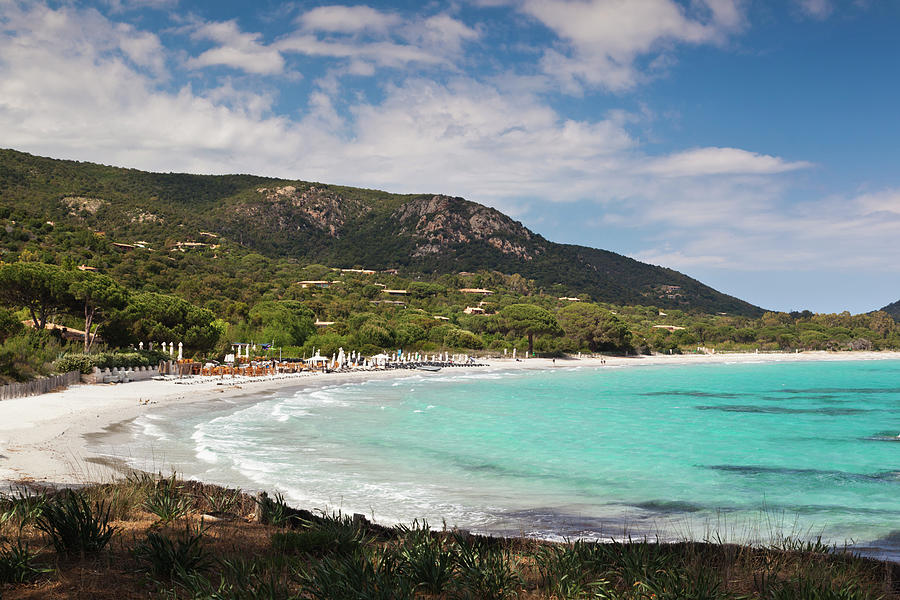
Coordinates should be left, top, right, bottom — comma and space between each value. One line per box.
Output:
0, 475, 900, 600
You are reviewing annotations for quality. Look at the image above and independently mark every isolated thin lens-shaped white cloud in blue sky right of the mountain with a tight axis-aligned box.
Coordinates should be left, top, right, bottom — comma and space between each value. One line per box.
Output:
643, 148, 812, 177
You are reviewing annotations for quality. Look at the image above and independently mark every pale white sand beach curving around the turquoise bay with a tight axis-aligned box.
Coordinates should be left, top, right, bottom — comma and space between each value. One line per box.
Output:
0, 352, 900, 484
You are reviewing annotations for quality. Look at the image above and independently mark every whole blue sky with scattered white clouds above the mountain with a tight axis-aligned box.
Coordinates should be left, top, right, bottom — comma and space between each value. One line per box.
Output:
0, 0, 900, 313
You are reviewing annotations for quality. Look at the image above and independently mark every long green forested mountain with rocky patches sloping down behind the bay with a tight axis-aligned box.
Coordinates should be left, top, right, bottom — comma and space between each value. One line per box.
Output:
0, 150, 763, 316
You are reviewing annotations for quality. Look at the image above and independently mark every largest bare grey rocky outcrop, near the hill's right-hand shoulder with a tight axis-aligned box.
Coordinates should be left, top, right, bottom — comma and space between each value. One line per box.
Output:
392, 196, 542, 260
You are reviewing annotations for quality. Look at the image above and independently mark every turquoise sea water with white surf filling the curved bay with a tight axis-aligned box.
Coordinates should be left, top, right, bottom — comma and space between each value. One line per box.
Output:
105, 360, 900, 557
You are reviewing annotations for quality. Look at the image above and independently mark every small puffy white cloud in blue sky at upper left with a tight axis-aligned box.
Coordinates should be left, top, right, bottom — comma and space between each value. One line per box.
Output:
186, 20, 284, 75
